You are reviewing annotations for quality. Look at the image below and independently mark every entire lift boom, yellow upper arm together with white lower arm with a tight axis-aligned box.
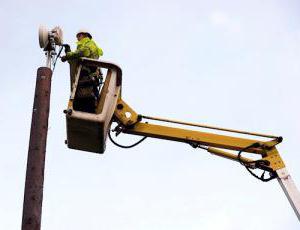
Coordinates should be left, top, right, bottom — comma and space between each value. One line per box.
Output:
114, 98, 300, 221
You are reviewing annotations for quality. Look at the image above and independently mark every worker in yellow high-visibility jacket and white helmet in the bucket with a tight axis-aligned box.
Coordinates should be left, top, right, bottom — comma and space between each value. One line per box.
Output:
61, 29, 103, 113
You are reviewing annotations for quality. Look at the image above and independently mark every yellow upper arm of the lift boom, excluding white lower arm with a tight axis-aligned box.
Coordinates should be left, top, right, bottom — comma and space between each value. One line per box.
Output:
114, 99, 284, 171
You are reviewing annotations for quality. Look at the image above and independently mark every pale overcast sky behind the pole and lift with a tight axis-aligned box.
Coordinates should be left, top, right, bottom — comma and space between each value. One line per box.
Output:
0, 0, 300, 230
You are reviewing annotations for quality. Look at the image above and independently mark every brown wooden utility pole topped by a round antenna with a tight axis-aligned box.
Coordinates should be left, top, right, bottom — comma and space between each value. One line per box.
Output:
22, 67, 52, 230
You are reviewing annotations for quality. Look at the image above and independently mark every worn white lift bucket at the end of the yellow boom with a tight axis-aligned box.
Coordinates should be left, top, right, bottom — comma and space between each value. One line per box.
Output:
65, 58, 122, 153
